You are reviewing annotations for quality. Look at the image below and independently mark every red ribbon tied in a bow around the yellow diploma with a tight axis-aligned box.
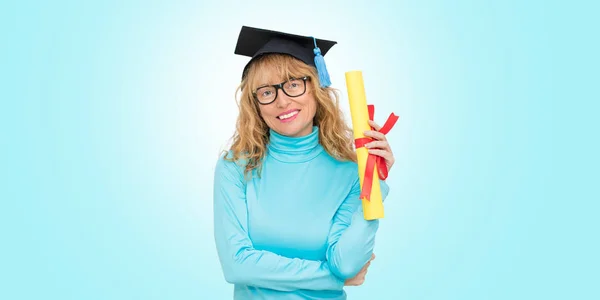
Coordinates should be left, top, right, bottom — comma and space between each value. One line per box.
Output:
354, 105, 399, 201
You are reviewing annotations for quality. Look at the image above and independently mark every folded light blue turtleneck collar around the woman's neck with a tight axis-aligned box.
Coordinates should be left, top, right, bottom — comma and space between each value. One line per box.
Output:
267, 126, 323, 163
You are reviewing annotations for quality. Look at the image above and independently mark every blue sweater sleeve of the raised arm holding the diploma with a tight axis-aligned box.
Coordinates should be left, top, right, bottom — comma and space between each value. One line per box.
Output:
327, 180, 389, 280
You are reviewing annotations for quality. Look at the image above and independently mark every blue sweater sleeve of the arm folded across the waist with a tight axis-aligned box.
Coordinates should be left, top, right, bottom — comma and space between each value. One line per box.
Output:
213, 159, 344, 291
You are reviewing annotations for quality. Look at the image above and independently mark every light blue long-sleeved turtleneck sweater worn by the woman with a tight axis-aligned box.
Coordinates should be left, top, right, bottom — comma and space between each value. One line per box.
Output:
214, 127, 389, 299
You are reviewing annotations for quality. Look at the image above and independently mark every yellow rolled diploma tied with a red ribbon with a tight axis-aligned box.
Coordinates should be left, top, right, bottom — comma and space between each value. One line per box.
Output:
346, 71, 383, 220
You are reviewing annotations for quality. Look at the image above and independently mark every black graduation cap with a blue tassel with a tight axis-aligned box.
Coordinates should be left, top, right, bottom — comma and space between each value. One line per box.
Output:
234, 26, 337, 87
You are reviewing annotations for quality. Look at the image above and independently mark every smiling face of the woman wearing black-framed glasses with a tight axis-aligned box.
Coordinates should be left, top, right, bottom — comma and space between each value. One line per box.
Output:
258, 76, 317, 137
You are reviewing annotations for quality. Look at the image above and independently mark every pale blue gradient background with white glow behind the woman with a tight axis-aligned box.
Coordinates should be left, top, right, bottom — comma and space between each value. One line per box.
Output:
0, 1, 600, 300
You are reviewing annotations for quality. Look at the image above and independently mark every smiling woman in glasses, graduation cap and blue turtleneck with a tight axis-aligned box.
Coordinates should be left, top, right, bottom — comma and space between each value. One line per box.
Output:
214, 27, 394, 299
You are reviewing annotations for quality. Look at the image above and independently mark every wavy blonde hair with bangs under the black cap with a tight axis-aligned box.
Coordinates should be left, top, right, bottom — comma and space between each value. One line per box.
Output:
224, 54, 356, 175
